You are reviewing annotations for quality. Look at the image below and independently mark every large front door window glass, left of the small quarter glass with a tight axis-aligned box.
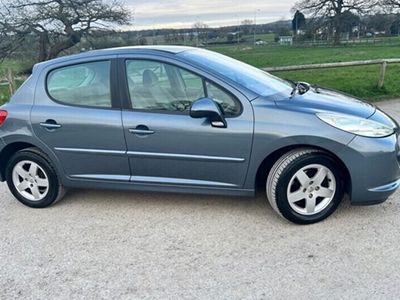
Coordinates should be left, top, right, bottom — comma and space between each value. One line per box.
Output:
126, 60, 204, 112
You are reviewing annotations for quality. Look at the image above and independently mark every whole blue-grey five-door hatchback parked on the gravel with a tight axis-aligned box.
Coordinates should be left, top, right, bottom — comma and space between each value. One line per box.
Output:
0, 46, 400, 224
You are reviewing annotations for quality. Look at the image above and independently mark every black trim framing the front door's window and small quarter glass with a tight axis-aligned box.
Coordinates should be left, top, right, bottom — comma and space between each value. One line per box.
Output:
118, 57, 243, 119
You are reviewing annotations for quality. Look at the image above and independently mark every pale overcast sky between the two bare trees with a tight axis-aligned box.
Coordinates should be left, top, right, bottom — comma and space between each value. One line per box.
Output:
124, 0, 296, 29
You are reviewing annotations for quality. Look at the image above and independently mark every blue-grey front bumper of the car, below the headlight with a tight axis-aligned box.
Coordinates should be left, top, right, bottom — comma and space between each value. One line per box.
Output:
339, 135, 400, 205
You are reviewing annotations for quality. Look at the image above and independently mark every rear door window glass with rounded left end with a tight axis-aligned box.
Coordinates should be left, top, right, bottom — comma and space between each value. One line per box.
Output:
47, 61, 111, 107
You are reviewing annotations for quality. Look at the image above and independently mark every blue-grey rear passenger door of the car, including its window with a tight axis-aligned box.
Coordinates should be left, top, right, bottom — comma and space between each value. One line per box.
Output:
31, 57, 130, 181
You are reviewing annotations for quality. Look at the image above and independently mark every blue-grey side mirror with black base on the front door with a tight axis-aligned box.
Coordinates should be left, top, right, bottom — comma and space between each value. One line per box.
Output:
190, 98, 227, 128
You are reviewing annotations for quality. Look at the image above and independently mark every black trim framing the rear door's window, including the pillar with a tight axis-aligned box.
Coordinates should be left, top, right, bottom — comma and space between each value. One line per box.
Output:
44, 58, 121, 110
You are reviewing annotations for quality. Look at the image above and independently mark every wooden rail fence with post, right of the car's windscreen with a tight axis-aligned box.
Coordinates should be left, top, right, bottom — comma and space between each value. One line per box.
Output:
262, 58, 400, 87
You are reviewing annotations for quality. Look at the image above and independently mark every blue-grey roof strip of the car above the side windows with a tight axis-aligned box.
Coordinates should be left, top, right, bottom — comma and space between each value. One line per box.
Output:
34, 46, 196, 68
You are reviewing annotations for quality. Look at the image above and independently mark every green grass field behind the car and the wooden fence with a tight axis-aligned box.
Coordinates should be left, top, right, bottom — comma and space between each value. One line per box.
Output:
0, 41, 400, 103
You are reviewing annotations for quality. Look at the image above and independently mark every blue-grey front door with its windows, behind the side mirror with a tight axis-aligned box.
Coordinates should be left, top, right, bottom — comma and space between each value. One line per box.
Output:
120, 58, 253, 189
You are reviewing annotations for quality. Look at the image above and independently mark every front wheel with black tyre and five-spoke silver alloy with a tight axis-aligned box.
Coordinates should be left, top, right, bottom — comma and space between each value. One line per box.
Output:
266, 148, 344, 224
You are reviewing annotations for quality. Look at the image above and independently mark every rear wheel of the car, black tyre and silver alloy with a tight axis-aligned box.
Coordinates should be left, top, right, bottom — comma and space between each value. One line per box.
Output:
6, 148, 65, 208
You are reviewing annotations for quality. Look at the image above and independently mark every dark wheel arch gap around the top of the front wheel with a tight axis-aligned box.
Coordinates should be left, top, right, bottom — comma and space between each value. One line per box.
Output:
254, 144, 351, 195
